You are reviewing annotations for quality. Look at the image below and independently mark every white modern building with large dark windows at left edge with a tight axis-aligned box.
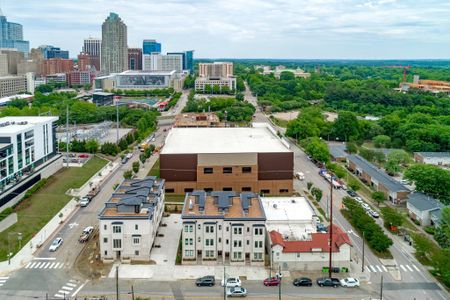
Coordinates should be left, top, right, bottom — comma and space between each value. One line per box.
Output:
0, 116, 58, 188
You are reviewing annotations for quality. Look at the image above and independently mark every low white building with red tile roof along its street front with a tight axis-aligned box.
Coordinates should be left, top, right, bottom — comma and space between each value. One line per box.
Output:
261, 197, 352, 271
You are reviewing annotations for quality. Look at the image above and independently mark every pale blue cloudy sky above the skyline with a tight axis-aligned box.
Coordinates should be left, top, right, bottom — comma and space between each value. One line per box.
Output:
0, 0, 450, 59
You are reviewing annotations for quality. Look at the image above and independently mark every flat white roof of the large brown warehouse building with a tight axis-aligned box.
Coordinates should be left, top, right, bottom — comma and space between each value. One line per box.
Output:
161, 125, 291, 154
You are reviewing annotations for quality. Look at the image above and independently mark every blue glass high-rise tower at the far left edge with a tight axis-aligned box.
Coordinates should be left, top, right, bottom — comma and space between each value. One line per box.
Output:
0, 9, 30, 57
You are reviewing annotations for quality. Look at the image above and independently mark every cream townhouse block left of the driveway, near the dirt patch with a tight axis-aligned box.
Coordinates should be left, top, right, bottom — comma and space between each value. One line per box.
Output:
99, 176, 164, 262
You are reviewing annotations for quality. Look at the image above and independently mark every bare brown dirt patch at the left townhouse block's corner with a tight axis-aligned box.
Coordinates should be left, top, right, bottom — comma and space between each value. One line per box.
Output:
75, 230, 112, 280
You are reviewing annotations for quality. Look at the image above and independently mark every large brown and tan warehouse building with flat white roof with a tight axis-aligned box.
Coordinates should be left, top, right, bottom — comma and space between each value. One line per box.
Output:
160, 123, 294, 195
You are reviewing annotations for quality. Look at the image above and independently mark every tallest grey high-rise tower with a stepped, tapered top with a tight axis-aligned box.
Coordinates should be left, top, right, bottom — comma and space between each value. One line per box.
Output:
100, 13, 128, 74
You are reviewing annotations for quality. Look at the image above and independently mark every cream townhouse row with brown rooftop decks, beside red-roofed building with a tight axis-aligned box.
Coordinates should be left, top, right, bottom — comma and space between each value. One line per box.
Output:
181, 191, 266, 266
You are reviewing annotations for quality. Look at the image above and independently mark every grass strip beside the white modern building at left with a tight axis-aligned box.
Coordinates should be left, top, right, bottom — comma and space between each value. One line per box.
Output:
0, 157, 107, 261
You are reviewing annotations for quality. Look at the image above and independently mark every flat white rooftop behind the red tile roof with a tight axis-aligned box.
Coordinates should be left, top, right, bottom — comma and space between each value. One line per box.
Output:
261, 197, 316, 240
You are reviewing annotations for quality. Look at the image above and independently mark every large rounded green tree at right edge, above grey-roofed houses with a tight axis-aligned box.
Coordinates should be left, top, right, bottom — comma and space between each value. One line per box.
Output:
404, 164, 450, 205
